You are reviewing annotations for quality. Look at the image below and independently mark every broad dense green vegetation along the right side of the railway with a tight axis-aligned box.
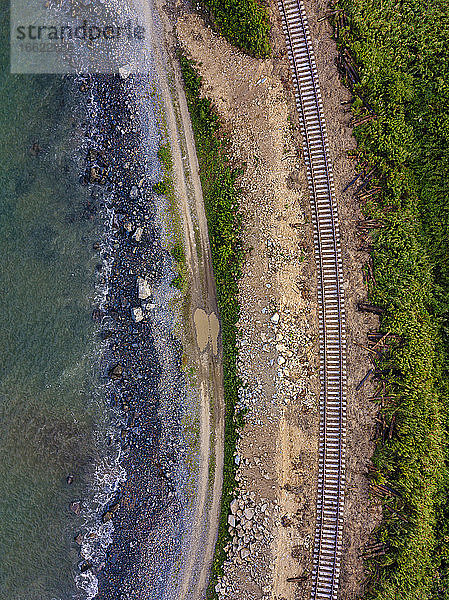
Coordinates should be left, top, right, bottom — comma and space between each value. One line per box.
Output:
334, 0, 449, 600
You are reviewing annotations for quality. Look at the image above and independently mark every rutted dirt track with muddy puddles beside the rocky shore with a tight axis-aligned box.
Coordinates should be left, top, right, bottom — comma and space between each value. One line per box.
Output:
137, 0, 224, 600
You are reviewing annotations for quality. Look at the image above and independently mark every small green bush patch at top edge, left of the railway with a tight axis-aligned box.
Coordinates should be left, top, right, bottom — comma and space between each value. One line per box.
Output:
197, 0, 271, 58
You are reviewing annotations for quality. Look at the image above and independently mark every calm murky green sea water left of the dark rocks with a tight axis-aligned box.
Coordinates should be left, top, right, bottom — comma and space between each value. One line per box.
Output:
0, 19, 100, 600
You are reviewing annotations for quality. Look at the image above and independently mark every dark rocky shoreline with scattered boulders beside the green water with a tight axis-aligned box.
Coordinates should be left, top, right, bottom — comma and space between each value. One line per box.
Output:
70, 76, 192, 599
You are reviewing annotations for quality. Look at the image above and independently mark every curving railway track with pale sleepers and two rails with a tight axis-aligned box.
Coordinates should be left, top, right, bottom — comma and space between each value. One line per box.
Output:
278, 0, 346, 600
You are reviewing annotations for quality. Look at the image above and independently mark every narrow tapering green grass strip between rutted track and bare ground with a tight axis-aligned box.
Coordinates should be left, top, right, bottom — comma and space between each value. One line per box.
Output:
180, 56, 243, 598
